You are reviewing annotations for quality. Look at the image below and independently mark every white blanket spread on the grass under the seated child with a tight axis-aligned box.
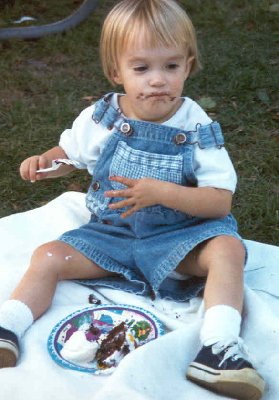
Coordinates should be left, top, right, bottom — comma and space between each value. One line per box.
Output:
0, 192, 279, 400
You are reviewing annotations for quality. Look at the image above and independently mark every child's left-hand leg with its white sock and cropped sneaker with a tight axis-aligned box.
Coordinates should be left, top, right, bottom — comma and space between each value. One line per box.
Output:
0, 241, 115, 368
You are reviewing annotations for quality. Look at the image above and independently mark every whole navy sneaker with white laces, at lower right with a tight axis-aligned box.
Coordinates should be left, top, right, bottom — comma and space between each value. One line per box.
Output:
186, 339, 265, 400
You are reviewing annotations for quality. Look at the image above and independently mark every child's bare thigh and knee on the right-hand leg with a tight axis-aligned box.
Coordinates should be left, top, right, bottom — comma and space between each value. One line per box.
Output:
176, 235, 245, 276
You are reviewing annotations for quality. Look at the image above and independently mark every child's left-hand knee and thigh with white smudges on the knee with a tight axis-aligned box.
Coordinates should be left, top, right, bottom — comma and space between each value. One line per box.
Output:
31, 240, 115, 280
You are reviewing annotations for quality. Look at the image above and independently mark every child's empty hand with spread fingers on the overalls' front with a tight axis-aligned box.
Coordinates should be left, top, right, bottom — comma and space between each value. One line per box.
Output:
105, 176, 167, 218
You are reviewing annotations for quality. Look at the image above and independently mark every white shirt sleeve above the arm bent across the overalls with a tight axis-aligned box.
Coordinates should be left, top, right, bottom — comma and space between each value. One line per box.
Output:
194, 145, 237, 193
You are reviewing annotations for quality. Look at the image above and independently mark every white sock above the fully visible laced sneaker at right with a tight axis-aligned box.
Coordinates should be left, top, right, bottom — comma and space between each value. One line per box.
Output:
200, 305, 241, 346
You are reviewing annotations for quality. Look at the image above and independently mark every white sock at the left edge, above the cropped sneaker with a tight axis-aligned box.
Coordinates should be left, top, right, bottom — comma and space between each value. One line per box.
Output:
0, 300, 34, 338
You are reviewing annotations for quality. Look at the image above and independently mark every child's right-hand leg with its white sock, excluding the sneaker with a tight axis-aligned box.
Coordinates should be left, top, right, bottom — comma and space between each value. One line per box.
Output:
178, 236, 245, 346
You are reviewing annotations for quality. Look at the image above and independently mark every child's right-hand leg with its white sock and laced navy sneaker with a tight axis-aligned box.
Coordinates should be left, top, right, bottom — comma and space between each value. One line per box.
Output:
178, 236, 264, 400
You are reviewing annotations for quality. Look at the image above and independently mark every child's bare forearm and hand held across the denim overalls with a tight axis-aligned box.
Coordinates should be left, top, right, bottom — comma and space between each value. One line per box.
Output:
105, 176, 232, 218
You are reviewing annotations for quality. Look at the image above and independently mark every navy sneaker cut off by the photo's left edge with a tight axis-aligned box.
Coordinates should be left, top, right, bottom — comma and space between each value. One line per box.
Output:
0, 327, 19, 368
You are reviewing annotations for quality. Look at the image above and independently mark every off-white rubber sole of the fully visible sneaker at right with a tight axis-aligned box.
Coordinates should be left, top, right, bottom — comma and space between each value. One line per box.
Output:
186, 362, 265, 400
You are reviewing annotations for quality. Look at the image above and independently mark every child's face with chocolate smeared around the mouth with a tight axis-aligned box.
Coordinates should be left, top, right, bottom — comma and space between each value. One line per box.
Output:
114, 40, 192, 123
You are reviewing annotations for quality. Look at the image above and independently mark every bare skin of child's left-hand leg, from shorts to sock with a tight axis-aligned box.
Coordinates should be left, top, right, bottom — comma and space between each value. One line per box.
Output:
11, 240, 114, 319
